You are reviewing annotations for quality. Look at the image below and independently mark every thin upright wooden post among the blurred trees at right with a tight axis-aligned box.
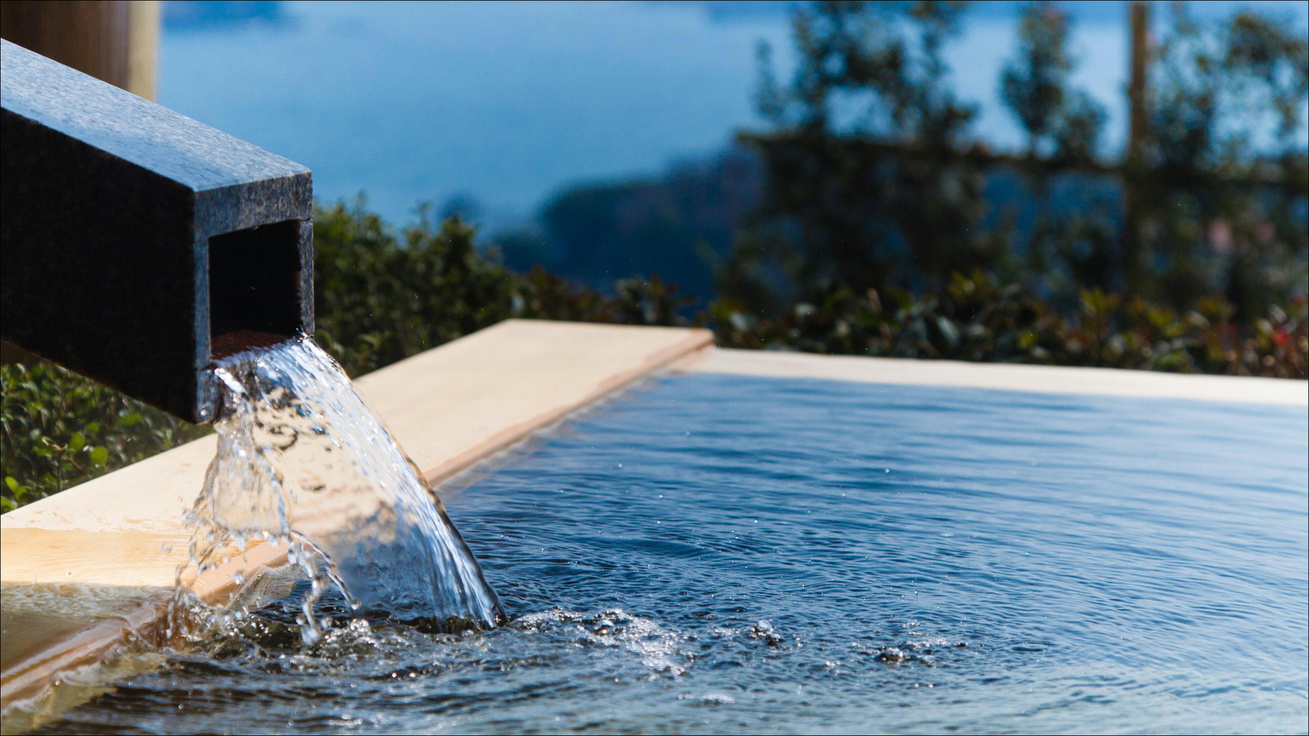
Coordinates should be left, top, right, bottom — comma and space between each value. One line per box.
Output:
1122, 0, 1149, 296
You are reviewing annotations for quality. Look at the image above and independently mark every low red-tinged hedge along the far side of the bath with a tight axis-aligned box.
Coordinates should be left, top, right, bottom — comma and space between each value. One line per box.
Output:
709, 270, 1309, 378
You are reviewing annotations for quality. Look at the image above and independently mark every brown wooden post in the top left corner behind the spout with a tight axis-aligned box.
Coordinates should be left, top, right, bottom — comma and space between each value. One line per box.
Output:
0, 0, 160, 100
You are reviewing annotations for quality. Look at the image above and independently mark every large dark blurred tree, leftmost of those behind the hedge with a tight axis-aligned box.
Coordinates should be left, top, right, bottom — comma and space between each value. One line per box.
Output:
720, 1, 1005, 310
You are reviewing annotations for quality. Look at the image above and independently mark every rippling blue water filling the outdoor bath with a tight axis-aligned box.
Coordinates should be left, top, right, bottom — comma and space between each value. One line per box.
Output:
35, 375, 1309, 733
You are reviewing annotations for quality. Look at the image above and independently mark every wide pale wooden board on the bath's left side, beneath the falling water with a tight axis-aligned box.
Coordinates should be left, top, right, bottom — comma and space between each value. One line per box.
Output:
0, 320, 712, 708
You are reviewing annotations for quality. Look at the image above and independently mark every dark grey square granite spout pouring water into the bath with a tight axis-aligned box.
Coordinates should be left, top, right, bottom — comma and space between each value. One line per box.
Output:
0, 41, 314, 422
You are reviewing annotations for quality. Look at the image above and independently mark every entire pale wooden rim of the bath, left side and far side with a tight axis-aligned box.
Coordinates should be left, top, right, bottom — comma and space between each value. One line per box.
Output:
0, 320, 1309, 711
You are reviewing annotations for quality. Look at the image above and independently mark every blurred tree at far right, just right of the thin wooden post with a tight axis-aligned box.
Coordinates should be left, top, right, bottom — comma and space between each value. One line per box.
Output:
1123, 5, 1309, 317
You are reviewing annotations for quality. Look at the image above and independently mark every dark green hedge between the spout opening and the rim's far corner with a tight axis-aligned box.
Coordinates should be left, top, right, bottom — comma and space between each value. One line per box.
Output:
314, 200, 686, 376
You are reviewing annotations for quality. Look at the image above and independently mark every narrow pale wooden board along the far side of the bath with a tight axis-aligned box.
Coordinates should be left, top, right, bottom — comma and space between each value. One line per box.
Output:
675, 348, 1309, 406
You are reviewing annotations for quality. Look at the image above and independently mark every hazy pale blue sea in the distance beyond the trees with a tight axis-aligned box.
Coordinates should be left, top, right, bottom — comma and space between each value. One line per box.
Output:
158, 1, 1309, 228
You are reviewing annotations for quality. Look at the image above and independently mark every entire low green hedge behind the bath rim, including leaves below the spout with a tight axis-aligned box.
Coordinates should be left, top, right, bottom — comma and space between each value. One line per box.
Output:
0, 203, 1309, 511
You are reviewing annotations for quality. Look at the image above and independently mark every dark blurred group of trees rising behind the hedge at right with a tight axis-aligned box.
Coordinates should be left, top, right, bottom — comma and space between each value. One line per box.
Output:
719, 0, 1309, 320
